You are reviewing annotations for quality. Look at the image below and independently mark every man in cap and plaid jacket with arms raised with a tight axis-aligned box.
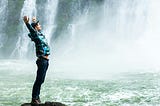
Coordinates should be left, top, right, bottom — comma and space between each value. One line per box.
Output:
23, 16, 50, 104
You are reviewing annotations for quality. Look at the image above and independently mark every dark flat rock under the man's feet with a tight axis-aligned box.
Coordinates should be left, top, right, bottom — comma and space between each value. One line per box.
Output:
21, 102, 66, 106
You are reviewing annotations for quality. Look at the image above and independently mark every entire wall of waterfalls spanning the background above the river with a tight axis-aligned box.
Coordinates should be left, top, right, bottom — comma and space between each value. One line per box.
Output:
0, 0, 160, 70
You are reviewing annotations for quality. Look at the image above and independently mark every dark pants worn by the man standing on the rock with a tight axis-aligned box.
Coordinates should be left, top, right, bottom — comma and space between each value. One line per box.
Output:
32, 58, 49, 99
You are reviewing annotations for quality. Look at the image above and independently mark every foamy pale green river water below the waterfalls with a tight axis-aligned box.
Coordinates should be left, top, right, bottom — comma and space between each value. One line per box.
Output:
0, 65, 160, 106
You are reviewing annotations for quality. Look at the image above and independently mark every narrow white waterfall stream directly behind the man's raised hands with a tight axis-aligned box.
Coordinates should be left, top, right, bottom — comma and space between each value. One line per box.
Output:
11, 0, 36, 58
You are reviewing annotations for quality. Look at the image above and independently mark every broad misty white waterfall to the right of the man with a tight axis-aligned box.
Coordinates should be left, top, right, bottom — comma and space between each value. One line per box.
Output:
54, 0, 160, 78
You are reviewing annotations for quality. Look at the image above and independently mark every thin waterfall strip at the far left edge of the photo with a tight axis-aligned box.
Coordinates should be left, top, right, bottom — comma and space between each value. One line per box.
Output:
0, 0, 8, 48
